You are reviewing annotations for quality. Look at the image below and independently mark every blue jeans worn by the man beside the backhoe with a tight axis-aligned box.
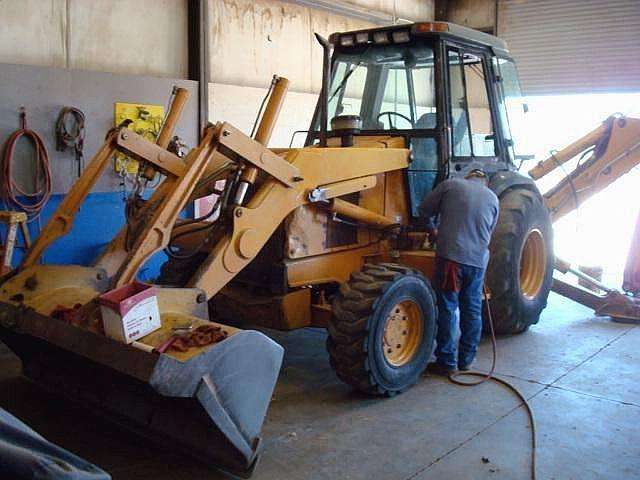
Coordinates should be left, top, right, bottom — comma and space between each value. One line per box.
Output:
435, 258, 484, 368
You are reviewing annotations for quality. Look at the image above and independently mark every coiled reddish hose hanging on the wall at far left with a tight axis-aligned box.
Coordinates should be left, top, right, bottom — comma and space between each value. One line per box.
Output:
1, 110, 52, 221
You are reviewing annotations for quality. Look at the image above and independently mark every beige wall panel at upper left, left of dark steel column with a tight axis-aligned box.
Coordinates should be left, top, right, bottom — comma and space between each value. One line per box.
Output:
0, 0, 187, 78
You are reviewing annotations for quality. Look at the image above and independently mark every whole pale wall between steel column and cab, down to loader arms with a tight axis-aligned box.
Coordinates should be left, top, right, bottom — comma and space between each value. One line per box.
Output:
209, 0, 434, 147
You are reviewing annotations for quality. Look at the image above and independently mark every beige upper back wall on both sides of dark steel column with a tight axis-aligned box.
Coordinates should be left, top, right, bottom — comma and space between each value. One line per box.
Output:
0, 0, 434, 146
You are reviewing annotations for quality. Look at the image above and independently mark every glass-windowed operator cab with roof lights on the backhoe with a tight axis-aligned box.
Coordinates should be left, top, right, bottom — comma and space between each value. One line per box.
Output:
307, 22, 525, 217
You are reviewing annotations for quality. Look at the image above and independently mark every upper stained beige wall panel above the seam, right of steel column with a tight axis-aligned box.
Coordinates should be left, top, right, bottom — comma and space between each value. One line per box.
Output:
209, 0, 372, 92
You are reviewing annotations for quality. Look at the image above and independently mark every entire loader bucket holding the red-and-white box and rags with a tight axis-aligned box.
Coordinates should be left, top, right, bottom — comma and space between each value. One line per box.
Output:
0, 266, 283, 476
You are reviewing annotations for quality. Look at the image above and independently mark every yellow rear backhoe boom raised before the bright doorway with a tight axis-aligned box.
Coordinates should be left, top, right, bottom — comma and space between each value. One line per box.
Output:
529, 116, 640, 222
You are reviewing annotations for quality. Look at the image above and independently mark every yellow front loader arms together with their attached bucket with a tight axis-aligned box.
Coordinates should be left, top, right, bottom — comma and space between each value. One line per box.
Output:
0, 79, 409, 473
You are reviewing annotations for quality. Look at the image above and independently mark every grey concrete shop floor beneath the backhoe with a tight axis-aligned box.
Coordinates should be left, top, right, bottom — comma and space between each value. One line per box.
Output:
0, 295, 640, 480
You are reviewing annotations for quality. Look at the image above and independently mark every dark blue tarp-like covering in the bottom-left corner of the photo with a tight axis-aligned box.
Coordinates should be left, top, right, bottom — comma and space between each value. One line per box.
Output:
0, 408, 111, 480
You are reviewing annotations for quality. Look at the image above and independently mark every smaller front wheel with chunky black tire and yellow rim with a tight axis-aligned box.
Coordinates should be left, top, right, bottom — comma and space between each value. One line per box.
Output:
327, 263, 437, 396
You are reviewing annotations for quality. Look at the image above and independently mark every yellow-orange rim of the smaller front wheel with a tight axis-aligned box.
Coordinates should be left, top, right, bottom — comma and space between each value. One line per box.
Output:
382, 300, 423, 367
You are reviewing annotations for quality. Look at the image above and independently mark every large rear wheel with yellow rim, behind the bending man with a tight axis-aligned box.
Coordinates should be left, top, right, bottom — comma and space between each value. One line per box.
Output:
485, 188, 554, 334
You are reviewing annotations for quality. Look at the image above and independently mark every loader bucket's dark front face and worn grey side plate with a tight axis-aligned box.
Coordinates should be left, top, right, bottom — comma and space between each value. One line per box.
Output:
0, 270, 283, 476
